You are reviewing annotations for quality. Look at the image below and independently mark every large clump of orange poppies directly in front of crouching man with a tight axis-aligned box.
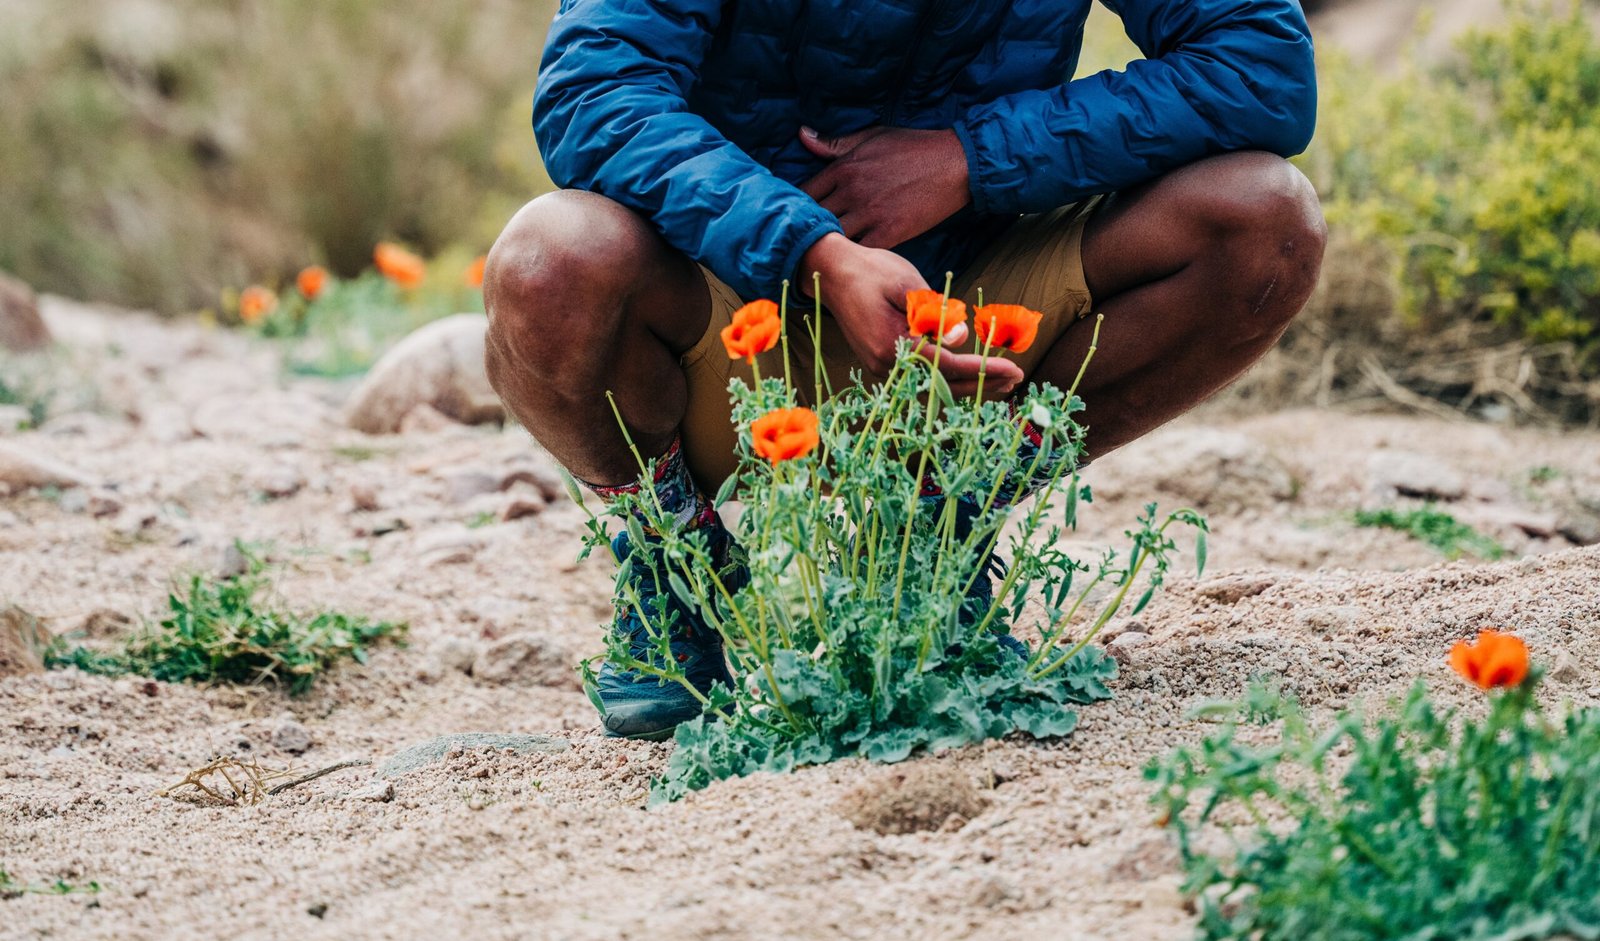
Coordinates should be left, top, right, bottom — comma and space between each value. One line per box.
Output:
578, 273, 1205, 800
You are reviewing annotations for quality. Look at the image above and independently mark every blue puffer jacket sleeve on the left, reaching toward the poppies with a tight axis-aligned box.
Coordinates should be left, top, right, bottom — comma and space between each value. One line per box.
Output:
533, 0, 840, 299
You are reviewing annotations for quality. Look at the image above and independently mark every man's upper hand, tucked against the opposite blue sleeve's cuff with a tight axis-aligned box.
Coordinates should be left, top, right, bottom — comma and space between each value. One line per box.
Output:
800, 128, 973, 248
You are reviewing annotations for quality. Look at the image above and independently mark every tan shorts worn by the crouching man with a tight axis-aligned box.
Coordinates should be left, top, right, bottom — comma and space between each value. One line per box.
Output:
682, 197, 1101, 493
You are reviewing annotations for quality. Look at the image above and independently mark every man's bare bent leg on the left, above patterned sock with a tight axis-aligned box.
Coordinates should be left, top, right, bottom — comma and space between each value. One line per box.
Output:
483, 190, 710, 485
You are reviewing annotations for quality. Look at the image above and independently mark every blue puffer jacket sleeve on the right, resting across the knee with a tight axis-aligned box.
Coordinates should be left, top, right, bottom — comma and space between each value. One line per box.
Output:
955, 0, 1317, 213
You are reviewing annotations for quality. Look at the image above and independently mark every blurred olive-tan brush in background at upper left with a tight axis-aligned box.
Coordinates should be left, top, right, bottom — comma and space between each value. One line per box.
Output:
0, 0, 555, 312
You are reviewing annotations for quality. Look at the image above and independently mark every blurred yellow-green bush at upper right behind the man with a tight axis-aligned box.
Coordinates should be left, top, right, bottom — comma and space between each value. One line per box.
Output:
1301, 3, 1600, 363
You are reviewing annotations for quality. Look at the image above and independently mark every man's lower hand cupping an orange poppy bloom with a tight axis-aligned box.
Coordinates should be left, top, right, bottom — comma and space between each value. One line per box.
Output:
800, 232, 1022, 397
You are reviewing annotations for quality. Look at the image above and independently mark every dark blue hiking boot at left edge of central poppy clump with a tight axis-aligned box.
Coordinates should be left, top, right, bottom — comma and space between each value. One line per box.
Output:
595, 522, 749, 741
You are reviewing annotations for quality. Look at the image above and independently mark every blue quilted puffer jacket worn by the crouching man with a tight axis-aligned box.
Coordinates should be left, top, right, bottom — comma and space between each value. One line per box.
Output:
533, 0, 1317, 299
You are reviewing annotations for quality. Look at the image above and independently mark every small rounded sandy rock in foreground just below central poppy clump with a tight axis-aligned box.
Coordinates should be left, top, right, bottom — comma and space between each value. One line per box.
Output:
835, 760, 989, 835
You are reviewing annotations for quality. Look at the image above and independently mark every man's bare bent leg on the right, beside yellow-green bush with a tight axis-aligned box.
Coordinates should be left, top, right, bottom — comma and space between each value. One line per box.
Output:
1029, 154, 1326, 456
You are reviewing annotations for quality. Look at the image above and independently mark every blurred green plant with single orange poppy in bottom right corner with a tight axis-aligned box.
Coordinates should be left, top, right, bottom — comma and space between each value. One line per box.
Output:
1146, 635, 1600, 941
